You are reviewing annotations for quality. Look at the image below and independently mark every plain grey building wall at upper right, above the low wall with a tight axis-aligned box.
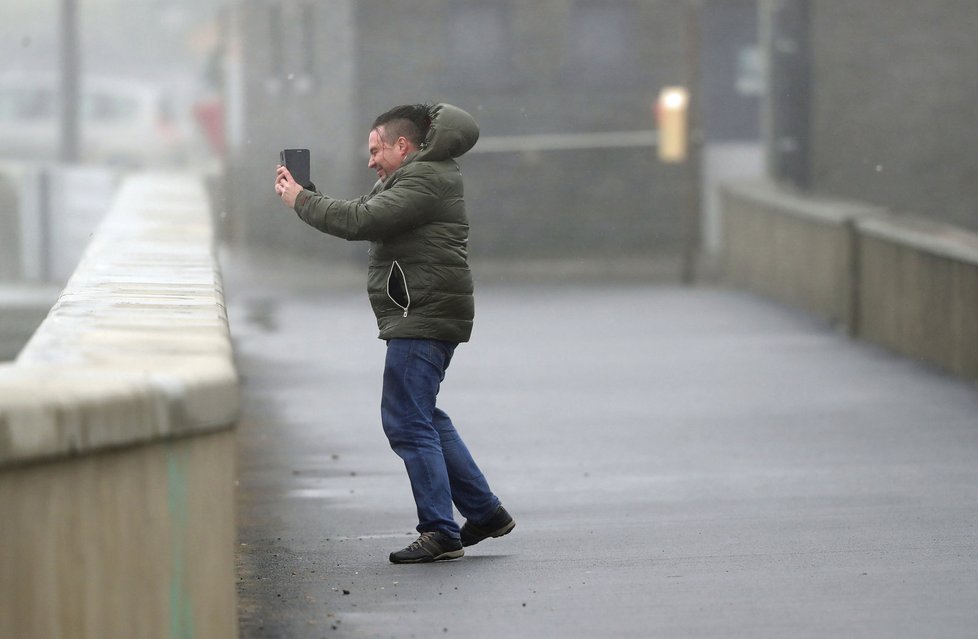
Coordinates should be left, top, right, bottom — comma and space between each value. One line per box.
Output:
810, 0, 978, 231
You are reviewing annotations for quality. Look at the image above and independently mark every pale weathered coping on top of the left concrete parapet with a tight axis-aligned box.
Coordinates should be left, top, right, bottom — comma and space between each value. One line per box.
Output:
0, 173, 239, 467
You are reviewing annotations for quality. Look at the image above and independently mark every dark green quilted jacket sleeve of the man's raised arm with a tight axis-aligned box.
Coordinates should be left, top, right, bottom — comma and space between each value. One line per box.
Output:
295, 172, 439, 241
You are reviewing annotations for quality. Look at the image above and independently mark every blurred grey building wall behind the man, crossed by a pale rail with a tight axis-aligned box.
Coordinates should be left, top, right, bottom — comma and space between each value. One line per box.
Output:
347, 0, 691, 259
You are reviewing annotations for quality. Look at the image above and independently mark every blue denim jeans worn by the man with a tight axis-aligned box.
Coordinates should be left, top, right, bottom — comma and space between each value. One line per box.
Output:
380, 339, 499, 539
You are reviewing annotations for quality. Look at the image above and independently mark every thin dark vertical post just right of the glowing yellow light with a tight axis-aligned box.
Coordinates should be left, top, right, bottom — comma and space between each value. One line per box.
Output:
682, 0, 703, 285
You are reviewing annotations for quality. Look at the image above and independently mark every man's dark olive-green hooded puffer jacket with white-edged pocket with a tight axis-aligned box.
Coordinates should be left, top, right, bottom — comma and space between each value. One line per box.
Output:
295, 104, 479, 342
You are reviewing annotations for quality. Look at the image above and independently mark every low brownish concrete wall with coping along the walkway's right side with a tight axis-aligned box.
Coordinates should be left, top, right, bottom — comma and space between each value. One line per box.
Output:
721, 182, 978, 379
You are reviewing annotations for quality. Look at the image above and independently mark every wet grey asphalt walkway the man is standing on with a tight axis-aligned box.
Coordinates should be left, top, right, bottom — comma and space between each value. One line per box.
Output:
225, 252, 978, 639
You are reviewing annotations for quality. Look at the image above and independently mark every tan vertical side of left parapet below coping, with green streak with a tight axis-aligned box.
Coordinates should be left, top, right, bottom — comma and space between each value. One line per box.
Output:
0, 431, 236, 638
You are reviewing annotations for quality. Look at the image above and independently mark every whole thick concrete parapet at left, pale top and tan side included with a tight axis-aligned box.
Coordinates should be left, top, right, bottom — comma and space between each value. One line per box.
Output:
0, 174, 239, 637
